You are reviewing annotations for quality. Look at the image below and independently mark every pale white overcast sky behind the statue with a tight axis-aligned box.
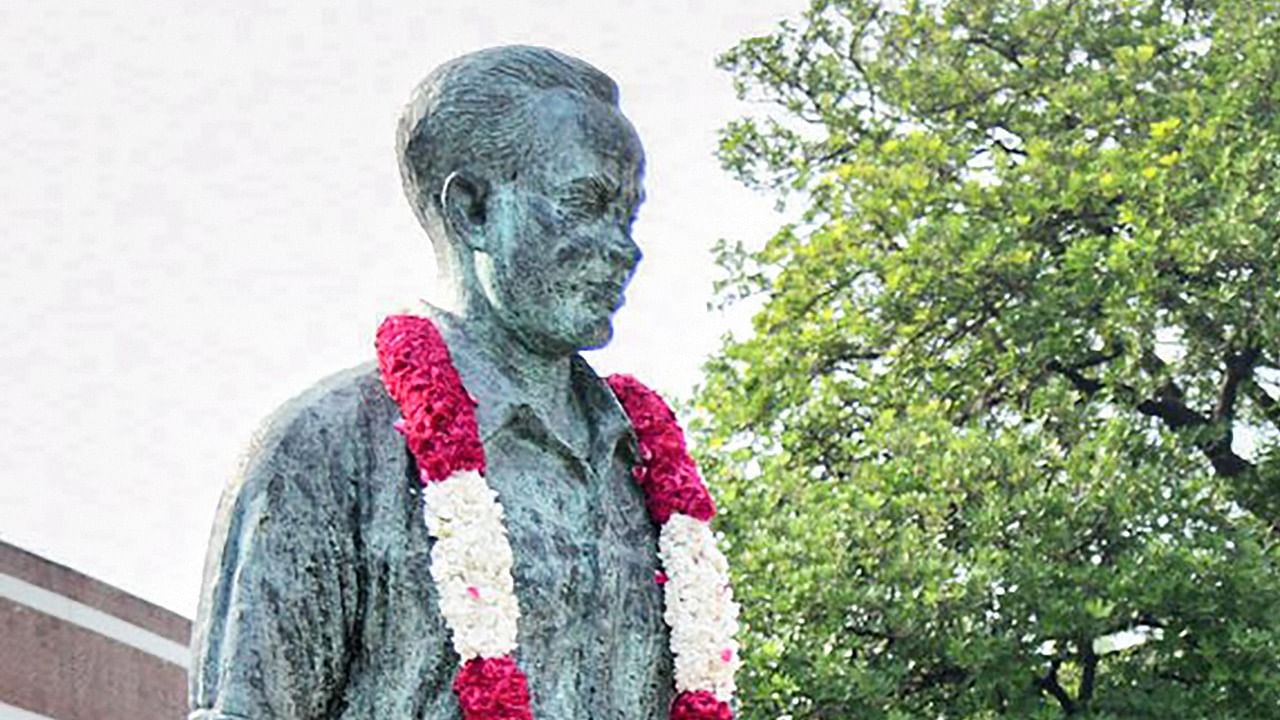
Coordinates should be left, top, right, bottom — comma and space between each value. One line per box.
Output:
0, 0, 804, 618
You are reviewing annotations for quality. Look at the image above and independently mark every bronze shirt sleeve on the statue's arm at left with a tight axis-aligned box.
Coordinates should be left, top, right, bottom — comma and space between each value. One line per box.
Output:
189, 401, 360, 720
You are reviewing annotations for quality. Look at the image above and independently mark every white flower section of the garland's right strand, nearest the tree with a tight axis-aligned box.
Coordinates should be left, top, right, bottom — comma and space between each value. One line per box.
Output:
658, 512, 740, 701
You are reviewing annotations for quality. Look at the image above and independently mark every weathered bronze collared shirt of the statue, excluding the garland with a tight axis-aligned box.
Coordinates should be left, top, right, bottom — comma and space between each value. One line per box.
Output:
189, 314, 673, 720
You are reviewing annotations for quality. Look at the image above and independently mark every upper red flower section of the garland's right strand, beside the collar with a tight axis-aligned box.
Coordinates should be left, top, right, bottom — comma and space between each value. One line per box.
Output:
607, 375, 716, 524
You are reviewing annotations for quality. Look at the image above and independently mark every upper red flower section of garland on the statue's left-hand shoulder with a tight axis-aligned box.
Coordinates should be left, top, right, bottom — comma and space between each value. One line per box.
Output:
375, 315, 485, 483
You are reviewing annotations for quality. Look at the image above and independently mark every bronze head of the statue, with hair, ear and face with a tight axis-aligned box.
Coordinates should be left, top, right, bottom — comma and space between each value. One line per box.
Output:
397, 46, 644, 355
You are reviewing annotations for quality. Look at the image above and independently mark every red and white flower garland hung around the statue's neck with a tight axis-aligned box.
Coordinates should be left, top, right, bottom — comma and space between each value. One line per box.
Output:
376, 315, 739, 720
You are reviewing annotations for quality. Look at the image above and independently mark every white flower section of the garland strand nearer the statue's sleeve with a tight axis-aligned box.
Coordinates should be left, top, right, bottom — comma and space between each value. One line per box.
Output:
422, 470, 520, 662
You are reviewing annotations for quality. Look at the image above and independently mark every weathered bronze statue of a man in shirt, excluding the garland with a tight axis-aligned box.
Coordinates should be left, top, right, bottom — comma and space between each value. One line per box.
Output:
191, 47, 731, 720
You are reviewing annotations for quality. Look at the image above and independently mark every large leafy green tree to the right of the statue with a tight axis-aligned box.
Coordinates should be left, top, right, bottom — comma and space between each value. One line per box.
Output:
694, 0, 1280, 720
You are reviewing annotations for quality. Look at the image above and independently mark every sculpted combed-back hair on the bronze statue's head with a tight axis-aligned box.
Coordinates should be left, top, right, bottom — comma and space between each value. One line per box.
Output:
396, 45, 618, 235
